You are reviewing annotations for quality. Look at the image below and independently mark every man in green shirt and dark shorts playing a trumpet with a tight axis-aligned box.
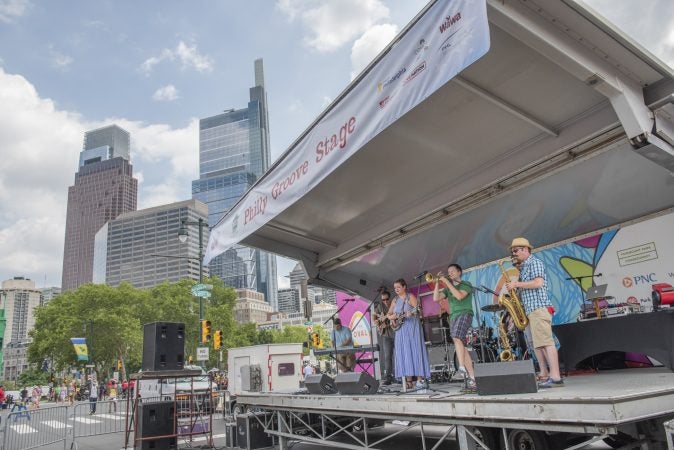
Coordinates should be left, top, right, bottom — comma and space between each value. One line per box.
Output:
433, 263, 476, 390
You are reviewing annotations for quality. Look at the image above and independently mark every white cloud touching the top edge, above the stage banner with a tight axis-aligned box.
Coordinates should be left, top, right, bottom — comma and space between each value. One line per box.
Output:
276, 0, 389, 52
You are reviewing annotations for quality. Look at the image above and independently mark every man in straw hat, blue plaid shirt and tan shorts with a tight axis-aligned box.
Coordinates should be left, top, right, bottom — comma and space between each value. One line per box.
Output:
506, 237, 564, 388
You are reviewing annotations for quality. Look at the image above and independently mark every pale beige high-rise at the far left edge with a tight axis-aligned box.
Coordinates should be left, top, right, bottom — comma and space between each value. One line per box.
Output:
0, 277, 40, 380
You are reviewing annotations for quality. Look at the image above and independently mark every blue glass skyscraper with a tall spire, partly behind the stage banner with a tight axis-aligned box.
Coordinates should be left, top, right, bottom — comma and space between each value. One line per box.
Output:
192, 59, 277, 310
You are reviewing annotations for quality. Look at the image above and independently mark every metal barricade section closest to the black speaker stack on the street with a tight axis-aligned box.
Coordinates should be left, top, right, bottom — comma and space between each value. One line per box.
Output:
69, 400, 126, 442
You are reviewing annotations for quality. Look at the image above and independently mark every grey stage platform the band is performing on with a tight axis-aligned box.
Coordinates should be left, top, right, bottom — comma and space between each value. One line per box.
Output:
237, 368, 674, 433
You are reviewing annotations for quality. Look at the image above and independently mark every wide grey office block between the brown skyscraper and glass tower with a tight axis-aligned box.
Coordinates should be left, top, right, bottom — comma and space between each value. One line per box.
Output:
93, 199, 208, 288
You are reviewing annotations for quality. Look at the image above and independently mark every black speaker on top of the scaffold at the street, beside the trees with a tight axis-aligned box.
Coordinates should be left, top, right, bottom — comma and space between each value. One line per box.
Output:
143, 322, 185, 371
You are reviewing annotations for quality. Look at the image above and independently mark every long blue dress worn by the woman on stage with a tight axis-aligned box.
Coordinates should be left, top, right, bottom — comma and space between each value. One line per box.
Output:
393, 297, 431, 378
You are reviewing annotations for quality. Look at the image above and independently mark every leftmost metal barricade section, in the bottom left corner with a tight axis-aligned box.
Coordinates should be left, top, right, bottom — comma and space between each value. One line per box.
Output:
2, 404, 71, 450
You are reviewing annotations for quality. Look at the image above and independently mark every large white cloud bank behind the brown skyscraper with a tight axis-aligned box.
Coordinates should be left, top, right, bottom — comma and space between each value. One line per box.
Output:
0, 68, 199, 286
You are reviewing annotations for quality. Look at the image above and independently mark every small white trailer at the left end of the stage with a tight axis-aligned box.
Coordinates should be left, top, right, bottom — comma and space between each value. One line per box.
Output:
226, 344, 302, 414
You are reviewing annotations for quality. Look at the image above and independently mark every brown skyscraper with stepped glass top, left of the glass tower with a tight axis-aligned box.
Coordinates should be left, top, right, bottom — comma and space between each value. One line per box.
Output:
61, 125, 138, 292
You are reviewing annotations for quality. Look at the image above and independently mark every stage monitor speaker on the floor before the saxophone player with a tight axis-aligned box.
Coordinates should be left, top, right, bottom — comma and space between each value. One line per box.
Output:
475, 359, 538, 395
